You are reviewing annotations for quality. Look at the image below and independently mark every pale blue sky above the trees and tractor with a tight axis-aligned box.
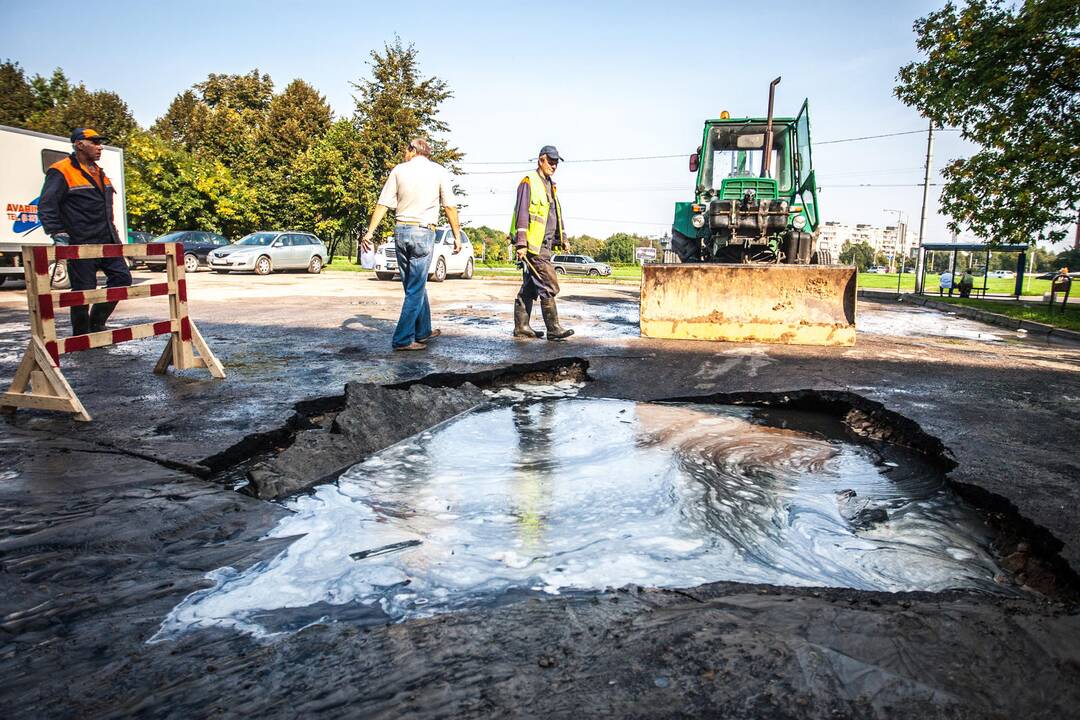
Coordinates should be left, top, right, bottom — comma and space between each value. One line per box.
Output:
0, 0, 1010, 242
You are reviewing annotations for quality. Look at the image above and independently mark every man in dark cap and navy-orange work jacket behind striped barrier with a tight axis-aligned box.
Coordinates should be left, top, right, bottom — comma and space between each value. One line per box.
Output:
38, 127, 132, 335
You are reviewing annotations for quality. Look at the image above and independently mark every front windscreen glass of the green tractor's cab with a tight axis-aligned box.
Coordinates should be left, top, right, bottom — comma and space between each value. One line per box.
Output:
701, 123, 793, 194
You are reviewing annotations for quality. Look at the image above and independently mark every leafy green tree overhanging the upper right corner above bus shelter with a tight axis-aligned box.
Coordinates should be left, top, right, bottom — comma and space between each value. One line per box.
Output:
895, 0, 1080, 244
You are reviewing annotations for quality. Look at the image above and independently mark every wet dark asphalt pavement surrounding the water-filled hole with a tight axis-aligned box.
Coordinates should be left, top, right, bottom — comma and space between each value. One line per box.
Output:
0, 273, 1080, 718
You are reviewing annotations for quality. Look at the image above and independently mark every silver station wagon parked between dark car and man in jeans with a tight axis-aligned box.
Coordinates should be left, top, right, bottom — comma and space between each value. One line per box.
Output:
208, 230, 329, 275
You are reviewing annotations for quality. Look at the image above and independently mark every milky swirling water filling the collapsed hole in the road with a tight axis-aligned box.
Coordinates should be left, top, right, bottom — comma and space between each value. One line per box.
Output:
157, 398, 1001, 640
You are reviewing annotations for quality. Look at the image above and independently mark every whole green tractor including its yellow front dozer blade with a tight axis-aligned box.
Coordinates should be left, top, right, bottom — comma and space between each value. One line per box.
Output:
640, 78, 856, 345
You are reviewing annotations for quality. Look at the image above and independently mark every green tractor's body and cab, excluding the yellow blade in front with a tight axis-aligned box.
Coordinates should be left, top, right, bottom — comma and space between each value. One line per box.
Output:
672, 78, 829, 264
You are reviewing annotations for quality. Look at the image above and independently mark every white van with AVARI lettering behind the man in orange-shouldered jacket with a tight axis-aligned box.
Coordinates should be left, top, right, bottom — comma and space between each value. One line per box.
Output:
0, 125, 127, 287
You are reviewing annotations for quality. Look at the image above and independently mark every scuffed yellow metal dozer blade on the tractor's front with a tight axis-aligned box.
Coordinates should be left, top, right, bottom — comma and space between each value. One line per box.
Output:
642, 262, 856, 345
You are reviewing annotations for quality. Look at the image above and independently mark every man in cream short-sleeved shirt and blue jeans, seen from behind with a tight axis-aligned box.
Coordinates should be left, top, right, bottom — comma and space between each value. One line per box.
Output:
360, 137, 461, 351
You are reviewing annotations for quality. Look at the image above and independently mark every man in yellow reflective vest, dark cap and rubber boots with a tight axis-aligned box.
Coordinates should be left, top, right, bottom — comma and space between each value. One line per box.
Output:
510, 145, 573, 340
